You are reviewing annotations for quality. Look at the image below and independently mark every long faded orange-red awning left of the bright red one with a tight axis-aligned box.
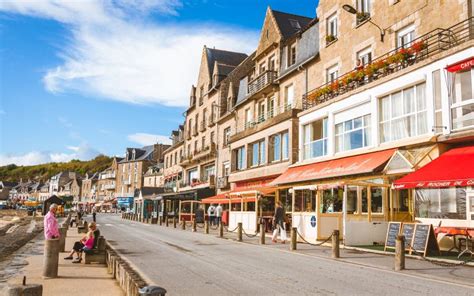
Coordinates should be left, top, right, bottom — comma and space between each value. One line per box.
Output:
272, 149, 396, 185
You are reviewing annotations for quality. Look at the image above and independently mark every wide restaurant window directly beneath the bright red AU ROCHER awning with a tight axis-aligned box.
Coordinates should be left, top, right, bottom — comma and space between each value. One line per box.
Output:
415, 187, 466, 220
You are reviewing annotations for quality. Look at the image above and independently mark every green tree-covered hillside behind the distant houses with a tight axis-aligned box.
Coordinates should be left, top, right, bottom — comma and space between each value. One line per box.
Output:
0, 155, 112, 182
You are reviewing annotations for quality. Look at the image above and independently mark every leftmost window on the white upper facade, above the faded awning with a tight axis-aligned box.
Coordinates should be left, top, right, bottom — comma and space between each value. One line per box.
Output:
303, 118, 328, 159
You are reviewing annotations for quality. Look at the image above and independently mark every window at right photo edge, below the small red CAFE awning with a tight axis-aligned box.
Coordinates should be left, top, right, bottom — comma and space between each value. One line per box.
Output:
451, 70, 474, 129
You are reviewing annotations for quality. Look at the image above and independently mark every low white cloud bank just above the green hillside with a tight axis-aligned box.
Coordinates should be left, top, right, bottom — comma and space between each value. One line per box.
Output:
0, 145, 100, 165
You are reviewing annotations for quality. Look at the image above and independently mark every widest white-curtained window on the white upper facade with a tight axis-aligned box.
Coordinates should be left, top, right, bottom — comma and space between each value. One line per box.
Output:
379, 83, 428, 143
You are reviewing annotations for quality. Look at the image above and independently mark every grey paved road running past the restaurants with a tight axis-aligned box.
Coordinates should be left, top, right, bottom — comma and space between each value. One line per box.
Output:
98, 215, 474, 296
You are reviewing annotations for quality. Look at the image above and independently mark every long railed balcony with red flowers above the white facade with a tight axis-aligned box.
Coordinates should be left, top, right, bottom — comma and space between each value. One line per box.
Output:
303, 18, 474, 110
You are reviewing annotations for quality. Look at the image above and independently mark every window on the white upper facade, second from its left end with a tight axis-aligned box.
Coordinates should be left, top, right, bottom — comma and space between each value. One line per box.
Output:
336, 114, 371, 152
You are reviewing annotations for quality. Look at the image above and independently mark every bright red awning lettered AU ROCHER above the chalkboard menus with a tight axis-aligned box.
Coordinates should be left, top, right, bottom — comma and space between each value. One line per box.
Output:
393, 146, 474, 189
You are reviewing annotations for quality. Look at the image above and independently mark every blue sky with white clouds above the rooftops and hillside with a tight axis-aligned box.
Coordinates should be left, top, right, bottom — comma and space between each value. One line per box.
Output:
0, 0, 317, 165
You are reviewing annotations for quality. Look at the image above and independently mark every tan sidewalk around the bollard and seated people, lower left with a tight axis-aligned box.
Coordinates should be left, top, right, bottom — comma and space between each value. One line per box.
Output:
8, 228, 125, 296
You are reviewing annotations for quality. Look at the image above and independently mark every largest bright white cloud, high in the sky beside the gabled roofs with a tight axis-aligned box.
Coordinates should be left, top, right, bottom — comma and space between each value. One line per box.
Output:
0, 0, 258, 106
